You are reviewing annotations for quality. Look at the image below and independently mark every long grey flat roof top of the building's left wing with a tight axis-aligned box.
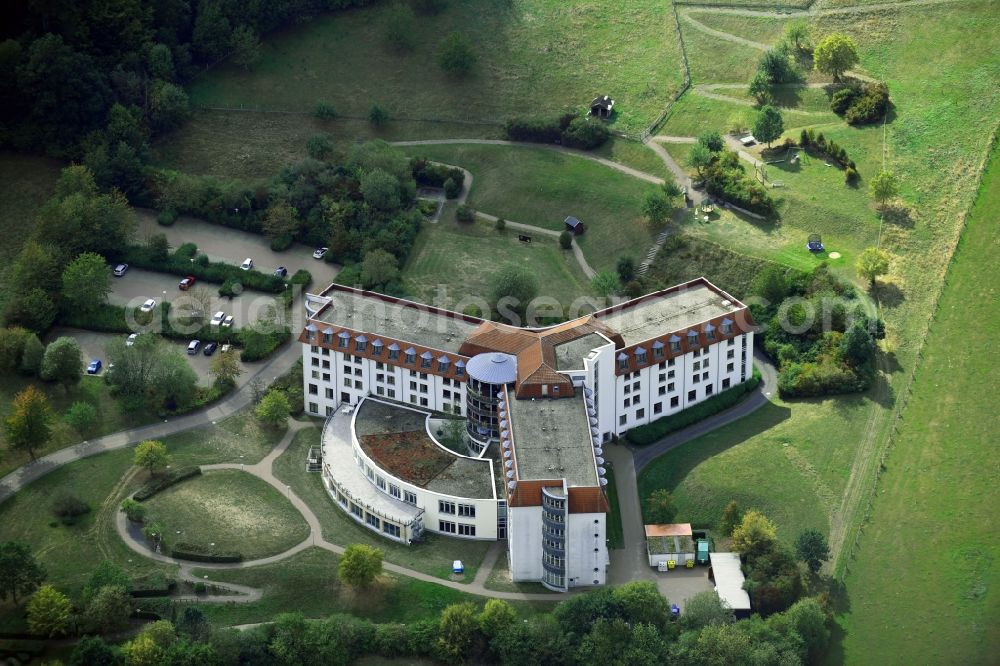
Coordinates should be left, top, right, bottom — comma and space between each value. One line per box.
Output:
314, 289, 479, 354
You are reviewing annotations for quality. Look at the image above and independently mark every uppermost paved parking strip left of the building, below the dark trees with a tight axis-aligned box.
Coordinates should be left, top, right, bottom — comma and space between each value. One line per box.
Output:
136, 209, 339, 288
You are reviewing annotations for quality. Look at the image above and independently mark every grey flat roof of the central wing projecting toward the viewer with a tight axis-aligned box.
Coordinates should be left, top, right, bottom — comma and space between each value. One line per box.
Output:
507, 391, 598, 487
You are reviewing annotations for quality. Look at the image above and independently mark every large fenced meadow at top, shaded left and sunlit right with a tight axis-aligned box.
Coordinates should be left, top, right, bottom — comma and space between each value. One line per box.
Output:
189, 0, 682, 132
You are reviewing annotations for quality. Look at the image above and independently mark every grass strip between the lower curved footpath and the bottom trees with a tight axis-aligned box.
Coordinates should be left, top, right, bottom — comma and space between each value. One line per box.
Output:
195, 548, 548, 625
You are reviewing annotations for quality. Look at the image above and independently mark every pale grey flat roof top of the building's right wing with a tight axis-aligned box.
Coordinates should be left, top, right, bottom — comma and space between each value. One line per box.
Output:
594, 281, 743, 347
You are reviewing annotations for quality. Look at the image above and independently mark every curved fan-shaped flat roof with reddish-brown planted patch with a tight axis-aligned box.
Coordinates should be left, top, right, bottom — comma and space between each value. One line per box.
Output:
354, 398, 494, 499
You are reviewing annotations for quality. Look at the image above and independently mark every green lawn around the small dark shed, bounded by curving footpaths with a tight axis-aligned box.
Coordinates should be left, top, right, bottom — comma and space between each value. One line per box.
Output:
398, 145, 657, 270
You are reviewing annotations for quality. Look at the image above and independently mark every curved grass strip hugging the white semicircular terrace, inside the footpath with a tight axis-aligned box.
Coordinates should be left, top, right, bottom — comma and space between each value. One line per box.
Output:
273, 427, 490, 581
